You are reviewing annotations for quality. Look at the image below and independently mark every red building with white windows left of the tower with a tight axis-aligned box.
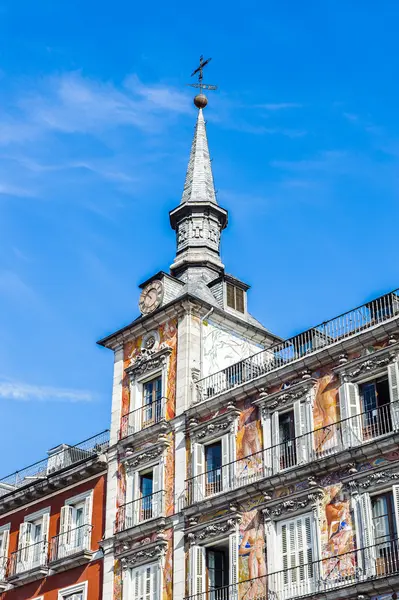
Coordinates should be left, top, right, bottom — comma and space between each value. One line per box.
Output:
0, 431, 109, 600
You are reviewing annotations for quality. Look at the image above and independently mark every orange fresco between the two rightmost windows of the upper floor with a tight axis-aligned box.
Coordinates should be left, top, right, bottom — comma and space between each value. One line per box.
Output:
313, 373, 340, 454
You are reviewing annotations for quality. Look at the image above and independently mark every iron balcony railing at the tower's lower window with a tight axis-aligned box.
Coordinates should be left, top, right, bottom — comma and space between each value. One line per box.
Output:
115, 490, 165, 532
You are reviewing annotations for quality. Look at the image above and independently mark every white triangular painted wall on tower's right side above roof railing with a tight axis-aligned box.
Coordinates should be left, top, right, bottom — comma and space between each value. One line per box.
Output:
203, 321, 262, 377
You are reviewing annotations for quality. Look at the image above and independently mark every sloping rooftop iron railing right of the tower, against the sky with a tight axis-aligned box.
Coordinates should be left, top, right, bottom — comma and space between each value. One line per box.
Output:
193, 288, 399, 403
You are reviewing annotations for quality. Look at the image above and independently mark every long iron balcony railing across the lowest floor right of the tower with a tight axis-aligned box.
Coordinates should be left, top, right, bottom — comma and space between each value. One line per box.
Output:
185, 539, 399, 600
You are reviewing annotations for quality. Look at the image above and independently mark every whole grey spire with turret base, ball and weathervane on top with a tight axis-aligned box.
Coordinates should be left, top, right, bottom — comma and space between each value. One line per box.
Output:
169, 61, 227, 283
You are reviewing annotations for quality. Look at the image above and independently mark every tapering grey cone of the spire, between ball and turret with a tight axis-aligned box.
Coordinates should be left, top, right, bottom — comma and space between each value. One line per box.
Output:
181, 109, 217, 204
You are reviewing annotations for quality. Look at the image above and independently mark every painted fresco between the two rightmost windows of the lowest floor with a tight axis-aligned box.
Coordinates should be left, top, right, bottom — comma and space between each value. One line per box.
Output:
320, 483, 356, 579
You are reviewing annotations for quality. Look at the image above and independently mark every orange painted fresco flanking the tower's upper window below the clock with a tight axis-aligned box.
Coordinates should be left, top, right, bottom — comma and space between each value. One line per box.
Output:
121, 319, 177, 419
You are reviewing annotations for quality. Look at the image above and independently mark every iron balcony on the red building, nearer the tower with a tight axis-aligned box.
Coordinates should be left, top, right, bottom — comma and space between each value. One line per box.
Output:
50, 525, 93, 571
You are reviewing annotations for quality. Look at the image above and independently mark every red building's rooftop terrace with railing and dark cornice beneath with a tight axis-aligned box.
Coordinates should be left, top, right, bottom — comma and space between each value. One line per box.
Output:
0, 430, 109, 510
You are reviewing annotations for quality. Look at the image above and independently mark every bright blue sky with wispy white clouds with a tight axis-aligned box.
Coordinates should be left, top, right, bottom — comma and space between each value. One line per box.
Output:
0, 0, 399, 475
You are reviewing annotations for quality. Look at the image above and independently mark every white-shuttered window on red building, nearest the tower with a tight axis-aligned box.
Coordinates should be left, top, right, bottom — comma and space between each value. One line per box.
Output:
56, 492, 92, 560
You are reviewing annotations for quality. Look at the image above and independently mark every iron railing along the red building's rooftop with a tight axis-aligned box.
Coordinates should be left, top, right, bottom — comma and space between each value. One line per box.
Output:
0, 430, 109, 497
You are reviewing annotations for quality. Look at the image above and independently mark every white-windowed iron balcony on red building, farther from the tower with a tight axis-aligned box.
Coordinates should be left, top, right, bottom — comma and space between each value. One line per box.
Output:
8, 540, 48, 585
